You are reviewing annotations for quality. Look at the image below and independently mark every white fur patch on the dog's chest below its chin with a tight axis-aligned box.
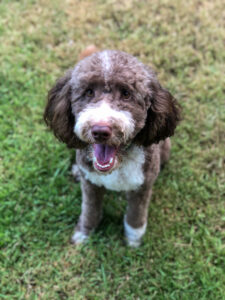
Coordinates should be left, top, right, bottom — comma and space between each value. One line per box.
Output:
80, 146, 145, 192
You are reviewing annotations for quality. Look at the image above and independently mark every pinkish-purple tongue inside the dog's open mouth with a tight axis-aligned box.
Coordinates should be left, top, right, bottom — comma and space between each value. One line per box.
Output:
94, 144, 116, 165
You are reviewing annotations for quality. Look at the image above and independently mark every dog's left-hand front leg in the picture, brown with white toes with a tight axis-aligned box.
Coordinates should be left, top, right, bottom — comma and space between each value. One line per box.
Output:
72, 177, 104, 244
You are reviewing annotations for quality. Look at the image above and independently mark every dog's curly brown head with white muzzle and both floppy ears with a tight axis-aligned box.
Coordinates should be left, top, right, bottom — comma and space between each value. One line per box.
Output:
44, 50, 180, 173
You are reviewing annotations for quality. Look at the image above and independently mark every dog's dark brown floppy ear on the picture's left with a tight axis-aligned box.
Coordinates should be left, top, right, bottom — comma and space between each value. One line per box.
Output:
44, 70, 81, 148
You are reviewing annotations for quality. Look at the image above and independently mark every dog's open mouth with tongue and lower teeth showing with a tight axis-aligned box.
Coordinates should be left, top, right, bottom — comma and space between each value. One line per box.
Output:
93, 144, 118, 172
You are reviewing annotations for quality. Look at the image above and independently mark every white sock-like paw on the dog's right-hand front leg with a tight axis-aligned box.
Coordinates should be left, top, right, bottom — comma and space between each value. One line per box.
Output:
124, 218, 147, 248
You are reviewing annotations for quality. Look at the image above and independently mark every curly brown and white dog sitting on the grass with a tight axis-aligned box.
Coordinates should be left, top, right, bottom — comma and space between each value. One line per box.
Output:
44, 48, 180, 247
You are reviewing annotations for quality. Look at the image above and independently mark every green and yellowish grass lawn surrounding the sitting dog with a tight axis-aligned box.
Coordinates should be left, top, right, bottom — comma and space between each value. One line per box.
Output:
0, 0, 225, 300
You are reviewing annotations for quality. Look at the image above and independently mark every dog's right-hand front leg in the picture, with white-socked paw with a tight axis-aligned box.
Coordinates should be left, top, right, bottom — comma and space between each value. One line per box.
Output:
124, 184, 152, 247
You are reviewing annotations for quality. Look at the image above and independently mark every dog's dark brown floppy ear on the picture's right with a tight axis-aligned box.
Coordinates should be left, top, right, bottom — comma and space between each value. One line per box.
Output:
137, 80, 181, 146
